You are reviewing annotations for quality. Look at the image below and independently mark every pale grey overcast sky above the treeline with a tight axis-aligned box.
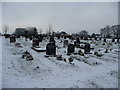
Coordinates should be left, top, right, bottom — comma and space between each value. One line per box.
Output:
2, 2, 118, 34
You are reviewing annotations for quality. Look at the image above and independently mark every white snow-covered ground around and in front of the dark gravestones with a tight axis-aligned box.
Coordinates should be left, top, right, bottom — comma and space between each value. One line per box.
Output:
2, 37, 118, 88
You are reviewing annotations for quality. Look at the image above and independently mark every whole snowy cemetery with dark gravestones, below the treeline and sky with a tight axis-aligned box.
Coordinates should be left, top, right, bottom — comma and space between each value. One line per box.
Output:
1, 28, 120, 88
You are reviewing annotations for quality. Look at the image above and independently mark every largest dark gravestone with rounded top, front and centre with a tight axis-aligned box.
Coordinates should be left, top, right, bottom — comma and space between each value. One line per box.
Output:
46, 42, 56, 57
